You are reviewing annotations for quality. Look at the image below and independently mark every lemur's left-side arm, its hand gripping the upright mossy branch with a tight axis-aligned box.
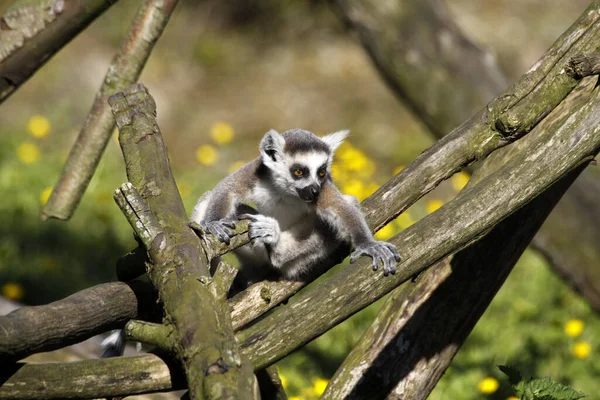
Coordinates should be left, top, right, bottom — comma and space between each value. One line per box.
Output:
191, 160, 259, 244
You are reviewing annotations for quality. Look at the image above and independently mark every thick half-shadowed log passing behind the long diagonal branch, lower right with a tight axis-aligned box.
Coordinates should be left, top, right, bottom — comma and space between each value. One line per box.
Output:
323, 79, 596, 400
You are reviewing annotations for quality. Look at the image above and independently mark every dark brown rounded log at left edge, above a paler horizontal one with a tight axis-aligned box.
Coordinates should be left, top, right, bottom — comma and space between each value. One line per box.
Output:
0, 281, 156, 360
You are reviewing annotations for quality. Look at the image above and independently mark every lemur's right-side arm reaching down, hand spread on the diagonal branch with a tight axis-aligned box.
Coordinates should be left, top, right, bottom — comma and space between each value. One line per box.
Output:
318, 181, 400, 275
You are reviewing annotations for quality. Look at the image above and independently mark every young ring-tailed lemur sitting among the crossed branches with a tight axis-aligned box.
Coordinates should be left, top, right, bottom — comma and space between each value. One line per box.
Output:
191, 129, 400, 287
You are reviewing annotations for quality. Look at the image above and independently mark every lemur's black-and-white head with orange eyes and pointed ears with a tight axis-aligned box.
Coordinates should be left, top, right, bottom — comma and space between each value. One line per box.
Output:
260, 129, 349, 203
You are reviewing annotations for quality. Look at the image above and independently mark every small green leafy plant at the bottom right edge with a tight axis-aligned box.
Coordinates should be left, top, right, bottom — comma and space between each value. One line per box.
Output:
498, 365, 586, 400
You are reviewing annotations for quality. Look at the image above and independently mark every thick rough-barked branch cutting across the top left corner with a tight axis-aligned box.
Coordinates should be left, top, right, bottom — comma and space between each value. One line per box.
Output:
0, 0, 116, 103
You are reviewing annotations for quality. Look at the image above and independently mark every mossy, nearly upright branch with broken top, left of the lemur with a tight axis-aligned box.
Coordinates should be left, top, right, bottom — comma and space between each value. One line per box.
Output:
109, 85, 254, 399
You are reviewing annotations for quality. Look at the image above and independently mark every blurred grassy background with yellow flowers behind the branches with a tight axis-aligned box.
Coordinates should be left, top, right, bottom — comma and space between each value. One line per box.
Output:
0, 0, 600, 400
